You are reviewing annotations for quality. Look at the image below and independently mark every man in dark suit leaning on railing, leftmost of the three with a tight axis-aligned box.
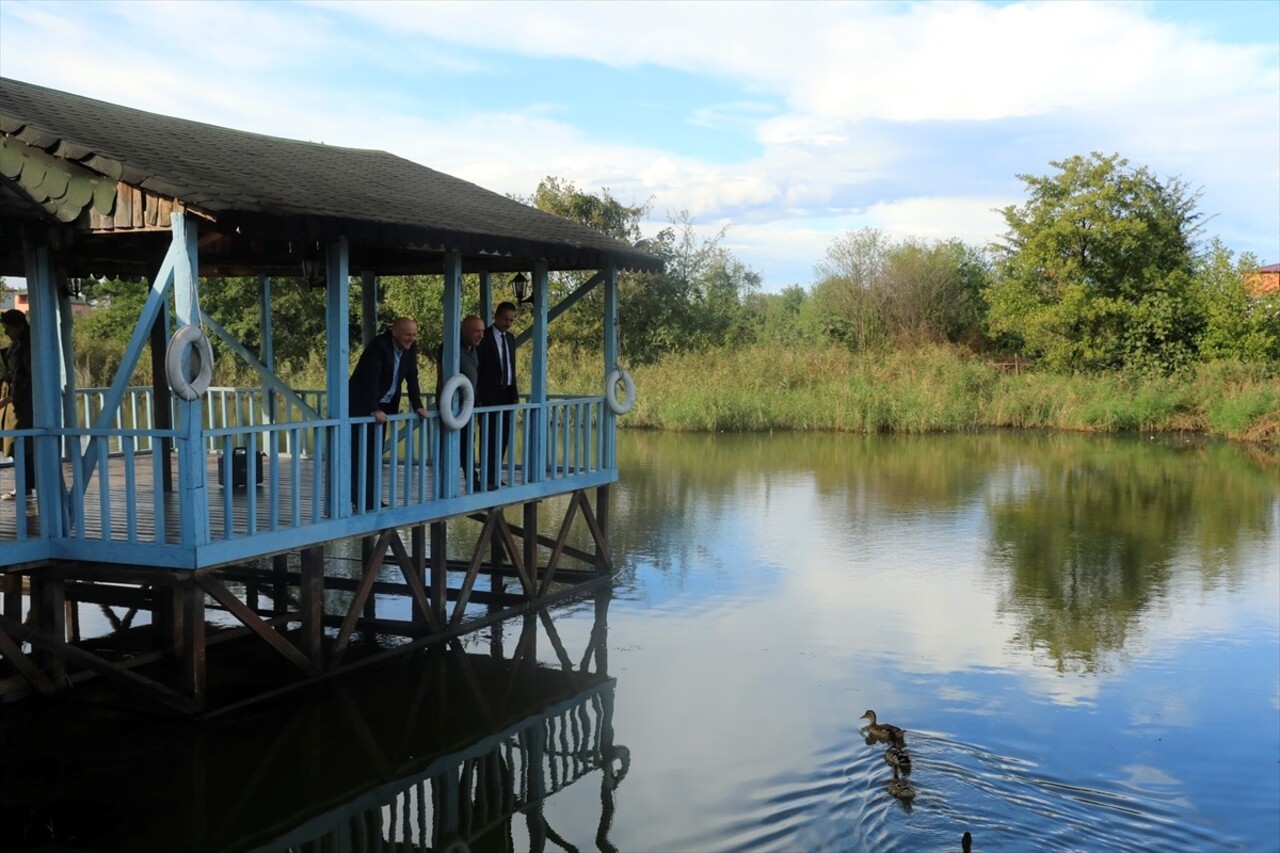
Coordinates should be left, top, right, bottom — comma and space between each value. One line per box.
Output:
347, 316, 426, 510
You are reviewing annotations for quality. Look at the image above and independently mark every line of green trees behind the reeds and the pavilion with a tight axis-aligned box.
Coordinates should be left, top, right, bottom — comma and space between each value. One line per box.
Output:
67, 152, 1280, 384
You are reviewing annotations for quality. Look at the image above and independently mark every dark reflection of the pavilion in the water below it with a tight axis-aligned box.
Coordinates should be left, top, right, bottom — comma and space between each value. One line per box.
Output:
0, 592, 619, 852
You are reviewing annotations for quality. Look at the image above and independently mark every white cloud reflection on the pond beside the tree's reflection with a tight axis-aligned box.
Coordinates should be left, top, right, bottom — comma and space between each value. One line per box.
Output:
711, 461, 1280, 706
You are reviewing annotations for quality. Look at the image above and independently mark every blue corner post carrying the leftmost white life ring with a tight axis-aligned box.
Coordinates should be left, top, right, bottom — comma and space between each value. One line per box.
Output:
172, 213, 208, 547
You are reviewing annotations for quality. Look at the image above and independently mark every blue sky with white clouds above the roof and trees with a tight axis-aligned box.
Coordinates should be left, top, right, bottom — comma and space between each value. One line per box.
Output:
0, 0, 1280, 291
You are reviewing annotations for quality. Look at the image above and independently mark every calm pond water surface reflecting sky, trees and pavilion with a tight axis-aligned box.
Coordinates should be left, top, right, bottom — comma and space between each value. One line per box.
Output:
0, 434, 1280, 852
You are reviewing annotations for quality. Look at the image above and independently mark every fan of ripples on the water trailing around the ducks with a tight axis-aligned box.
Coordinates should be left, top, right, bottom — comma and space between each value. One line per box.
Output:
677, 731, 1243, 853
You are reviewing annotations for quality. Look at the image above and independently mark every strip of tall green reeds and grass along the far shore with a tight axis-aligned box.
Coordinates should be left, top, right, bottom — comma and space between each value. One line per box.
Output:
549, 345, 1280, 447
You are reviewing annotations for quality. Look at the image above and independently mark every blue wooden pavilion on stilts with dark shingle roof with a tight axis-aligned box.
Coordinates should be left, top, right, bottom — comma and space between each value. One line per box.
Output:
0, 78, 662, 713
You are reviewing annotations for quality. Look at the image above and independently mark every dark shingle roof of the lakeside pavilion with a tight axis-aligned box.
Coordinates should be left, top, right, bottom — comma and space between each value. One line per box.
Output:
0, 78, 662, 272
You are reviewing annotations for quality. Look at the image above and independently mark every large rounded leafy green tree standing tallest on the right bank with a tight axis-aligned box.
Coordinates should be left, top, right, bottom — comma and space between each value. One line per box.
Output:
986, 152, 1202, 370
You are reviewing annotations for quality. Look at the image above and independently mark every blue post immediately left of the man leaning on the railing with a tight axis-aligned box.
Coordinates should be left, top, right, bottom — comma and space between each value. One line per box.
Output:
325, 237, 350, 519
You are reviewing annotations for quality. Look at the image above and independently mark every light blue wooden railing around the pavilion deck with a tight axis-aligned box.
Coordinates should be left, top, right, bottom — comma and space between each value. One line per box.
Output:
0, 388, 608, 565
